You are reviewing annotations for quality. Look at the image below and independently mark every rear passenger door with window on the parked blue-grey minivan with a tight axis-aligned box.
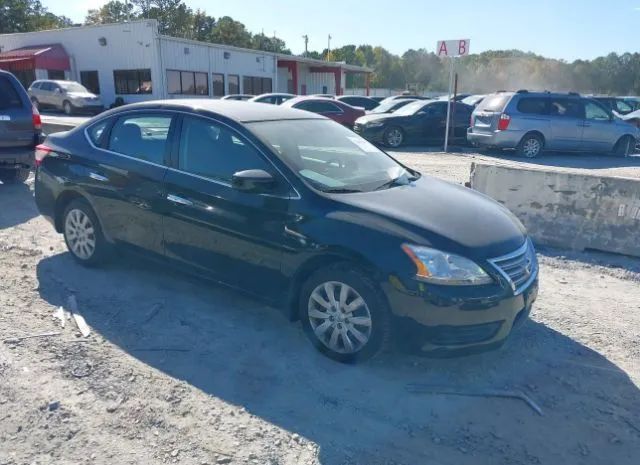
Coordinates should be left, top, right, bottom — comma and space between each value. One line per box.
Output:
546, 97, 585, 150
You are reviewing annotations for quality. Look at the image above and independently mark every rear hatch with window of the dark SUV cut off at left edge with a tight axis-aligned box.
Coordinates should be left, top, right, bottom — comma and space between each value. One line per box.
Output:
0, 74, 35, 149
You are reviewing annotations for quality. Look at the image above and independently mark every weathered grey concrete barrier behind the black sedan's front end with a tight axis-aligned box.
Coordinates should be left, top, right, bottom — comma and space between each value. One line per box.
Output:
471, 163, 640, 257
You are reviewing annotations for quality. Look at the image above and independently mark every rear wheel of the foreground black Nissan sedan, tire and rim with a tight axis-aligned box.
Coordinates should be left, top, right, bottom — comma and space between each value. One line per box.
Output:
62, 199, 109, 267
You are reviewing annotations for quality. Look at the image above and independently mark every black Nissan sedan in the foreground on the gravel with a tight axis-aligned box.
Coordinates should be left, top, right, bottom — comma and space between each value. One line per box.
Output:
35, 100, 538, 362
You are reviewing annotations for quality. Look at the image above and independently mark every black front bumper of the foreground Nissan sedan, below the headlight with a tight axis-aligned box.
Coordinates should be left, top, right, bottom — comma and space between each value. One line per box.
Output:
383, 276, 538, 356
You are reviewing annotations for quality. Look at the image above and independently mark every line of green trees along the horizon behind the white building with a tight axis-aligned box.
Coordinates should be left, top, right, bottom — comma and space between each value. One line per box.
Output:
0, 0, 640, 95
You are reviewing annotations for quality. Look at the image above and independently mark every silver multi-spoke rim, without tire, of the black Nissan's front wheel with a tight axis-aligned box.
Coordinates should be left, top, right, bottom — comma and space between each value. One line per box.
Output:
307, 281, 372, 354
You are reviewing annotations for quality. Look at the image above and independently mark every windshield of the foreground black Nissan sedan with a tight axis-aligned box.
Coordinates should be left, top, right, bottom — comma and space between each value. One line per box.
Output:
247, 119, 416, 193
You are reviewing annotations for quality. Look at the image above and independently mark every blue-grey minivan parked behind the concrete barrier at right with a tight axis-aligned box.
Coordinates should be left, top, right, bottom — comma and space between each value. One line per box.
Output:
467, 91, 640, 158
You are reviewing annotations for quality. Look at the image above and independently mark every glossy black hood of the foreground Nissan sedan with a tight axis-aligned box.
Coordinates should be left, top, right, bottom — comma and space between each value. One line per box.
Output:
333, 176, 526, 259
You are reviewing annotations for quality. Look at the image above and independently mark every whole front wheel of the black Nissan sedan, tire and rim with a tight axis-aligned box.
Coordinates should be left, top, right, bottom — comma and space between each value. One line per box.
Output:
298, 263, 391, 363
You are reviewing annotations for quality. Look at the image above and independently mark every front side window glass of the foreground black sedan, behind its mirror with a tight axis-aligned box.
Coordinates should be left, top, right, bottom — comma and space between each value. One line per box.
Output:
178, 117, 272, 182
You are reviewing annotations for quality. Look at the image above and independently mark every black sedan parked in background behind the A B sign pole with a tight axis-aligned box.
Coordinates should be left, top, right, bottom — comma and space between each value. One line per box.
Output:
354, 100, 473, 148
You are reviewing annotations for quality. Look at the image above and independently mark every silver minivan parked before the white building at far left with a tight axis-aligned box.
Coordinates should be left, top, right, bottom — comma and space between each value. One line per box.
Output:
29, 80, 104, 115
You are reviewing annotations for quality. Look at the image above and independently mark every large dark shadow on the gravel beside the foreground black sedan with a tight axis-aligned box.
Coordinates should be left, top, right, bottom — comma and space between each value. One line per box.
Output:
37, 253, 640, 465
